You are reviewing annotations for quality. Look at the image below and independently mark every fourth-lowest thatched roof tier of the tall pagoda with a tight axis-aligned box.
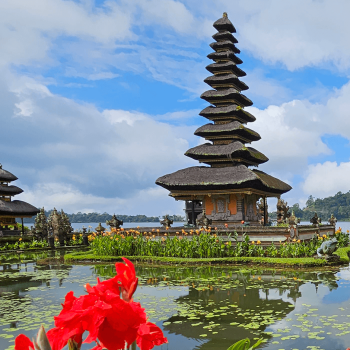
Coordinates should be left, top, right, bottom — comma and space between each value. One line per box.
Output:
199, 104, 256, 123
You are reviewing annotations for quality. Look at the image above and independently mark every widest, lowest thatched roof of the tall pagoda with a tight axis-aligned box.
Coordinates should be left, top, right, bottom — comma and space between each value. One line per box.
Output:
156, 165, 291, 194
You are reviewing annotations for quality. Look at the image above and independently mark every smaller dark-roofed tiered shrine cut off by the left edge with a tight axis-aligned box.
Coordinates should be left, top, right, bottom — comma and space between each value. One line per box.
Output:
0, 164, 39, 232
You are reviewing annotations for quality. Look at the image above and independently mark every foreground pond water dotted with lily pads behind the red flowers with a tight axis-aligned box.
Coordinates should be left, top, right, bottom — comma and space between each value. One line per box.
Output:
0, 252, 350, 350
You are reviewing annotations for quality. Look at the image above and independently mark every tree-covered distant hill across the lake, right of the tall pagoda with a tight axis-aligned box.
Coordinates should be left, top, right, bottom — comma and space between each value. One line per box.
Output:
269, 191, 350, 223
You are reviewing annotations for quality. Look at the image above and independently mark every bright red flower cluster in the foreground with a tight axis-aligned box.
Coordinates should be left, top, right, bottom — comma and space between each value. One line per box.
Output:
15, 258, 167, 350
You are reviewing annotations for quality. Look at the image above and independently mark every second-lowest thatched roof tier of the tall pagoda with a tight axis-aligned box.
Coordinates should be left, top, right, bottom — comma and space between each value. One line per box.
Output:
185, 141, 269, 164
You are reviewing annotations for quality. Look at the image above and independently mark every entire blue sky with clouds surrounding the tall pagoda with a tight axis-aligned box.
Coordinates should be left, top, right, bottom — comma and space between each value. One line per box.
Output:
0, 0, 350, 216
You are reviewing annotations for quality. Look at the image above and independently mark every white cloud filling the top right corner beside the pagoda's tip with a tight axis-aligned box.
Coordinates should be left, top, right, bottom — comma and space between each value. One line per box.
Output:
201, 0, 350, 71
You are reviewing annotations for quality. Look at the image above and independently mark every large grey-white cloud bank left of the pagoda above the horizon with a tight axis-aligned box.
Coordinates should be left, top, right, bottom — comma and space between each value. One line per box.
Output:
0, 69, 197, 215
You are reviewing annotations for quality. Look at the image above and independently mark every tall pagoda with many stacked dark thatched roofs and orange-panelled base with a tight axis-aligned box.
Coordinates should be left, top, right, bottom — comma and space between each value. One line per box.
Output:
156, 13, 291, 225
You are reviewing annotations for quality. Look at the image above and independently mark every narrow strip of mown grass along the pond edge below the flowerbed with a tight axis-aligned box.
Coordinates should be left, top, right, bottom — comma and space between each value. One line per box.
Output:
64, 247, 350, 267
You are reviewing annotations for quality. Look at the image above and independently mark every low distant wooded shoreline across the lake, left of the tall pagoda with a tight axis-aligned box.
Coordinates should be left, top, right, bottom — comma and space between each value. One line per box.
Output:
18, 209, 185, 223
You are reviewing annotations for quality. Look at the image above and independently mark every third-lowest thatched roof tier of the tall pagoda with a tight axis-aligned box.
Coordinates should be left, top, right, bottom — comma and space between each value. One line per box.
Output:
194, 121, 261, 141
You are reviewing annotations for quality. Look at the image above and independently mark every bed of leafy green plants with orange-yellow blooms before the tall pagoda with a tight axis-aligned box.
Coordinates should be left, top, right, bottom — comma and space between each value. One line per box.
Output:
89, 229, 349, 258
